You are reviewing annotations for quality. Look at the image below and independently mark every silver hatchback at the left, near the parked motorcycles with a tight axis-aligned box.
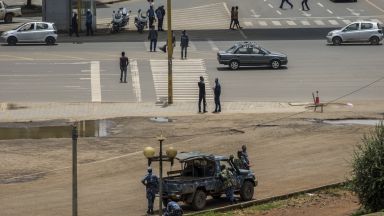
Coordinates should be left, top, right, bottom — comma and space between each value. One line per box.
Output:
1, 22, 57, 45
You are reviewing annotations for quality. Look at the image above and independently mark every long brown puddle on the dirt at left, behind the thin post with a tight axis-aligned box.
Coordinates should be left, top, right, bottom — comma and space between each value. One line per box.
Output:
0, 119, 113, 140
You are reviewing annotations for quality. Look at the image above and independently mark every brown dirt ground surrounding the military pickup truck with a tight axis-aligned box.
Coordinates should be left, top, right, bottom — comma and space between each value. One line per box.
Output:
0, 101, 384, 216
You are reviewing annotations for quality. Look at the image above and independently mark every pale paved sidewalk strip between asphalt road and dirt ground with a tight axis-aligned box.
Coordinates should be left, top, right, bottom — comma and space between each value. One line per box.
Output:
0, 102, 305, 122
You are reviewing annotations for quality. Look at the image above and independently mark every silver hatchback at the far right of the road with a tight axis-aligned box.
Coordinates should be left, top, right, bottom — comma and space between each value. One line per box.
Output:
326, 21, 383, 45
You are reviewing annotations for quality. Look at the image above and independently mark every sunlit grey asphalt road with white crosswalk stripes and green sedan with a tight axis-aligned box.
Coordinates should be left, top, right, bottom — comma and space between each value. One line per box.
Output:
0, 40, 384, 102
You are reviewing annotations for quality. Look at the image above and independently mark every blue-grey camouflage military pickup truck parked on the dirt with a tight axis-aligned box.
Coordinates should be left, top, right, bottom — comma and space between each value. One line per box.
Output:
162, 152, 257, 210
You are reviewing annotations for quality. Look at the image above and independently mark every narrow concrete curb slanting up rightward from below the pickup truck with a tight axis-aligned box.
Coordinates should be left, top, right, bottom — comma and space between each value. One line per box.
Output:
185, 181, 347, 216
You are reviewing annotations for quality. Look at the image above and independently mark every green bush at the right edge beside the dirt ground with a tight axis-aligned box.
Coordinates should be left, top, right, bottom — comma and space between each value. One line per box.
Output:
351, 121, 384, 212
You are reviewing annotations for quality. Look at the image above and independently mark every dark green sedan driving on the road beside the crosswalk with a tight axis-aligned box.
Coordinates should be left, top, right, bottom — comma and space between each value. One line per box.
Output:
217, 42, 288, 70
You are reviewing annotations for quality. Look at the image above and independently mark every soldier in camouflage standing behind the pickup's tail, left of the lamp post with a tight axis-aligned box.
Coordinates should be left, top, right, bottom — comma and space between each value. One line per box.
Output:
141, 167, 159, 214
